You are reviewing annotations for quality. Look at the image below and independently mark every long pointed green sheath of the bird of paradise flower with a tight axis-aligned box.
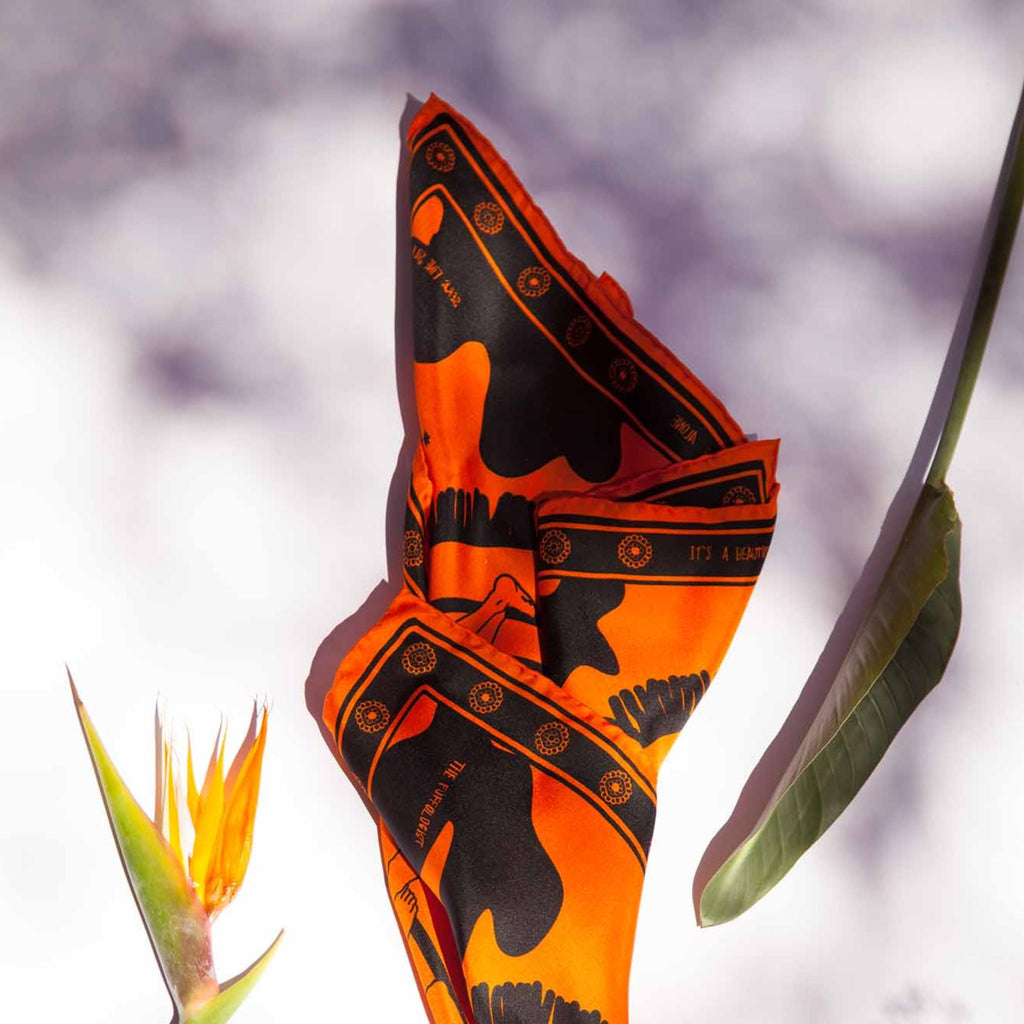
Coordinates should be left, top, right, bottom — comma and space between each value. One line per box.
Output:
68, 672, 218, 1016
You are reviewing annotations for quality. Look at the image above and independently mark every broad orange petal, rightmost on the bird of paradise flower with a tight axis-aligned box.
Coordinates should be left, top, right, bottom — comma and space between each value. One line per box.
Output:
203, 710, 267, 918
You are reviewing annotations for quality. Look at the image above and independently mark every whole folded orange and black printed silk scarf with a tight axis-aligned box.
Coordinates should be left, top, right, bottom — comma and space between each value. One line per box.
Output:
324, 96, 778, 1024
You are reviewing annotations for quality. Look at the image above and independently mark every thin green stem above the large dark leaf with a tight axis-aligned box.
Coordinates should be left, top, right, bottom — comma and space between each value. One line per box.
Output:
926, 77, 1024, 487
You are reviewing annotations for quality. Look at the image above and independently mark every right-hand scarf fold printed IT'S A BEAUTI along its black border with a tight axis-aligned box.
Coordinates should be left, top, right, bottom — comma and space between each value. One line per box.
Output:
536, 441, 778, 763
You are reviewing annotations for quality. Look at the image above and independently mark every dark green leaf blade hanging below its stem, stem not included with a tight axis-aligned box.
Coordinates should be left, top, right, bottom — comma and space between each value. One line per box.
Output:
699, 485, 961, 925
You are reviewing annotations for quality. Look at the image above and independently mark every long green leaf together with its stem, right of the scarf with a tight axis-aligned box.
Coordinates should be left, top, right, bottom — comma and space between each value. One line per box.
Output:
697, 77, 1024, 925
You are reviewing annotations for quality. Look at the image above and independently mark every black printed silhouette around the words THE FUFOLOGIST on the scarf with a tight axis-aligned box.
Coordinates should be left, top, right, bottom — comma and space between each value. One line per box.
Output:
371, 692, 562, 956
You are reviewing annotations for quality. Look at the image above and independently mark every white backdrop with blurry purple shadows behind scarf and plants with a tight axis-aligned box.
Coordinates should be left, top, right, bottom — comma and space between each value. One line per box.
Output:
0, 0, 1024, 1024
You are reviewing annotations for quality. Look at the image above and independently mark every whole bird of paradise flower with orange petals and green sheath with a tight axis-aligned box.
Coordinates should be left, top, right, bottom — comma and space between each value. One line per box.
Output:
68, 672, 284, 1024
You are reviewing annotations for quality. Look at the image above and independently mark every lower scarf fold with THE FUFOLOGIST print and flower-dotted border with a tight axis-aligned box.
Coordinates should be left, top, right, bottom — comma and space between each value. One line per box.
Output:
325, 592, 655, 1021
